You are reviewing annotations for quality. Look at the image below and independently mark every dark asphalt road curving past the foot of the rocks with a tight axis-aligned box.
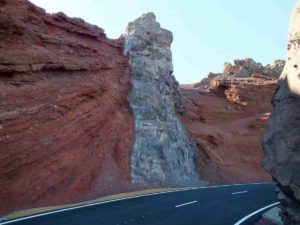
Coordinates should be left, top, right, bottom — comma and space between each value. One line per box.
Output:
0, 184, 277, 225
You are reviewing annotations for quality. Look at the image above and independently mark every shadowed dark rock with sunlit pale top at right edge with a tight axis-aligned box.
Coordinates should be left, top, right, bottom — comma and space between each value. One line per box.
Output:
263, 1, 300, 225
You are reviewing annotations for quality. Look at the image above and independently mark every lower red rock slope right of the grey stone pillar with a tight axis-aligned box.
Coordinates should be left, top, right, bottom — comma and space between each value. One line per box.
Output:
181, 59, 282, 184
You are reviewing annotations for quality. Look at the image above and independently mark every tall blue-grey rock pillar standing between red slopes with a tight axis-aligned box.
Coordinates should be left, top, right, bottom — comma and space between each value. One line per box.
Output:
124, 13, 198, 184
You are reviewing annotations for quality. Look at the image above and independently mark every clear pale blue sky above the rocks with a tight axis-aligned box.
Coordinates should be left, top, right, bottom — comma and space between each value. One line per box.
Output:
31, 0, 296, 84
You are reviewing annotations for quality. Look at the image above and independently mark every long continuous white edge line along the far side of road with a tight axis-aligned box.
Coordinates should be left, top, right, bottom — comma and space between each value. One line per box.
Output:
0, 182, 274, 225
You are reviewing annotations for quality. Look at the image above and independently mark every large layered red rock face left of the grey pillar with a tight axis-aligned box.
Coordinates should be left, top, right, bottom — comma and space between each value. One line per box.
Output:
0, 0, 134, 215
